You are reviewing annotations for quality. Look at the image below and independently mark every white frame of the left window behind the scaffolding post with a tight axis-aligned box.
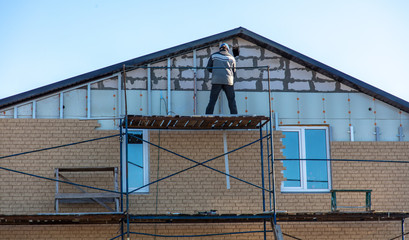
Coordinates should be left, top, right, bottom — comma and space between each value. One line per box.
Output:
122, 129, 149, 194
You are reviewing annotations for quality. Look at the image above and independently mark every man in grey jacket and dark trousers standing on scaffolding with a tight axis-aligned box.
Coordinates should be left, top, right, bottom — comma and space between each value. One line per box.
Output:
206, 43, 237, 114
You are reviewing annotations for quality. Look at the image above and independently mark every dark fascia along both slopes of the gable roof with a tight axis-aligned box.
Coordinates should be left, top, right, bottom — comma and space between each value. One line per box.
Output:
0, 27, 409, 113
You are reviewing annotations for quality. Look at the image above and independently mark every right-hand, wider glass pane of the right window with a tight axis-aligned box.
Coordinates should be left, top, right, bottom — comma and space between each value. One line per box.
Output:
305, 129, 328, 189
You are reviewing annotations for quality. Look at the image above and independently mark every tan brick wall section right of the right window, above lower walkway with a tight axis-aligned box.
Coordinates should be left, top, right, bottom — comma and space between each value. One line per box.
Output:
331, 142, 409, 212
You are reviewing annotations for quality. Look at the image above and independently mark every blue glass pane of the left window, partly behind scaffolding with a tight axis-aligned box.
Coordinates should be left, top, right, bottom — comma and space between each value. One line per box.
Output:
128, 133, 144, 189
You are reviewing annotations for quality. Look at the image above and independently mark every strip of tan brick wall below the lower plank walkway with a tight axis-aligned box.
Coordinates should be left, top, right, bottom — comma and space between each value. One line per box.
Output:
0, 221, 408, 240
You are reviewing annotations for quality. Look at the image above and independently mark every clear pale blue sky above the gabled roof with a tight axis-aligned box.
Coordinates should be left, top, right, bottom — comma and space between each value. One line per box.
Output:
0, 0, 409, 101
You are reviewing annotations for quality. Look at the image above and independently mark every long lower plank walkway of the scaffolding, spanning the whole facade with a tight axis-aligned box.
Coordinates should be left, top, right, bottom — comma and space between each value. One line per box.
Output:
0, 212, 409, 225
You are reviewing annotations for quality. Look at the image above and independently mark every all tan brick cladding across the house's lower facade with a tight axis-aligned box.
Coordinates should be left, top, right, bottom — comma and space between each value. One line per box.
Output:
0, 119, 409, 239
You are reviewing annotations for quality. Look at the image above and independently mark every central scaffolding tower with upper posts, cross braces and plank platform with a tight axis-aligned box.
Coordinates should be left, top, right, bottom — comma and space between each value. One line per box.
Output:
115, 61, 277, 240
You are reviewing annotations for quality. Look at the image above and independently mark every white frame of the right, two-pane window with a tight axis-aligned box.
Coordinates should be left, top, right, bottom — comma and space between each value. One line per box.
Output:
280, 126, 332, 193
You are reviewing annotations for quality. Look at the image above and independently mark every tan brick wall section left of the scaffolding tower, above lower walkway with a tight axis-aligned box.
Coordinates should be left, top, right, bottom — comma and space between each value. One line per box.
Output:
0, 119, 119, 214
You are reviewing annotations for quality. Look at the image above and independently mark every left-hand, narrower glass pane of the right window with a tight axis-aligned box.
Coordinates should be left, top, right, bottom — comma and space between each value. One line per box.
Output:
283, 132, 301, 187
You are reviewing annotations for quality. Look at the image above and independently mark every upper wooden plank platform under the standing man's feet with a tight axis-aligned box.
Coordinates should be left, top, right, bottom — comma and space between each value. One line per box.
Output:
128, 115, 270, 130
